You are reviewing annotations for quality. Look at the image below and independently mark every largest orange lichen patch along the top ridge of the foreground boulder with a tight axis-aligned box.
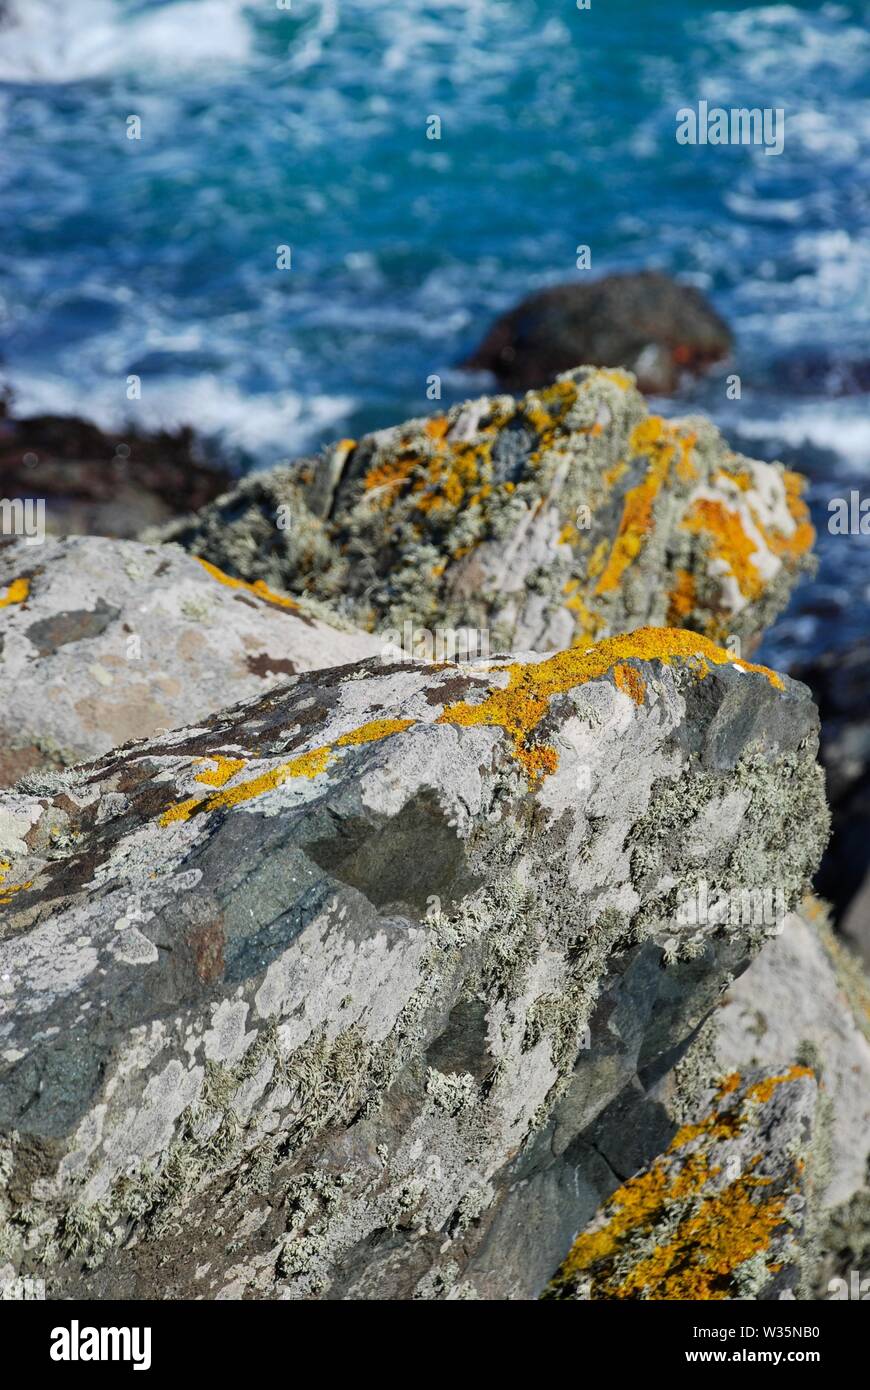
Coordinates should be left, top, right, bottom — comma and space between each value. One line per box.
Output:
439, 627, 784, 778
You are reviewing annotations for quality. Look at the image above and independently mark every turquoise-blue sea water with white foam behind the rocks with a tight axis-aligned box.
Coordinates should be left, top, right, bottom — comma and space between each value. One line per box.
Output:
0, 0, 870, 657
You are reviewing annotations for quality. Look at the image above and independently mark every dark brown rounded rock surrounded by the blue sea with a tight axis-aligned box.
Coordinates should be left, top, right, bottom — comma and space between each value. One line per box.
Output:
463, 271, 731, 395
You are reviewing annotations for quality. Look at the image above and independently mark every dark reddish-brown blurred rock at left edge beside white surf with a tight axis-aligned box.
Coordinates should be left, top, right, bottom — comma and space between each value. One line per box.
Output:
0, 410, 231, 538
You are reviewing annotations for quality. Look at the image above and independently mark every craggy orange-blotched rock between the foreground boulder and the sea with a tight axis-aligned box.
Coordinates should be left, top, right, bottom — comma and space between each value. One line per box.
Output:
152, 368, 813, 656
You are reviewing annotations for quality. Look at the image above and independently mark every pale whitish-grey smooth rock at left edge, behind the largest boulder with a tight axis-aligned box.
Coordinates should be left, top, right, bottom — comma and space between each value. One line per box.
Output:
0, 537, 381, 785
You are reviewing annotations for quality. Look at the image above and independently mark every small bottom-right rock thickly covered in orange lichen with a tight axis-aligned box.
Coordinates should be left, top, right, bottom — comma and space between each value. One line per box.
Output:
545, 1065, 817, 1300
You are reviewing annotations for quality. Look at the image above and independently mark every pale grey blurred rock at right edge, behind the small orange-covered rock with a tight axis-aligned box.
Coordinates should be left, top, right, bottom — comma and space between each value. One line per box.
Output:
714, 898, 870, 1297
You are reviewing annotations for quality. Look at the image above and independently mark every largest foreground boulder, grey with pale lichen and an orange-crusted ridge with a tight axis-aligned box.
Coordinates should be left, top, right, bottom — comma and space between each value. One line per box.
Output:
0, 630, 827, 1300
